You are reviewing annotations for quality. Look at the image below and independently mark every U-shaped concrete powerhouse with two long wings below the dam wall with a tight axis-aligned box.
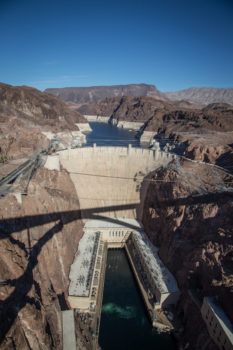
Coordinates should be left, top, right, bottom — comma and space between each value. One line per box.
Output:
68, 218, 180, 324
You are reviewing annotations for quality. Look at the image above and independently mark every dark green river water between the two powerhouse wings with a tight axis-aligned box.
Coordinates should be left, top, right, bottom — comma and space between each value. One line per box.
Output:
99, 249, 176, 350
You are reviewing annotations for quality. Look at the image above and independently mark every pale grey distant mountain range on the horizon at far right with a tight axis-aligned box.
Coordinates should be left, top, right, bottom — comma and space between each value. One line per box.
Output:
164, 87, 233, 105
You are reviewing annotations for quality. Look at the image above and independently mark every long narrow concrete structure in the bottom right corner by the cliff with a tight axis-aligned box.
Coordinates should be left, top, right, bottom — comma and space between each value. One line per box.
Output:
201, 297, 233, 350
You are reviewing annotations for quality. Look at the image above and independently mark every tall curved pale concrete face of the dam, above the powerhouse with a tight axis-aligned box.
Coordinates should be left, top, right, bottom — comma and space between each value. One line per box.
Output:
59, 145, 175, 220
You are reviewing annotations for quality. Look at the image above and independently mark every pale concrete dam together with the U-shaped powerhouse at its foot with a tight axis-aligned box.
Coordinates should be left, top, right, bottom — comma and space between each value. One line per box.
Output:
45, 145, 180, 350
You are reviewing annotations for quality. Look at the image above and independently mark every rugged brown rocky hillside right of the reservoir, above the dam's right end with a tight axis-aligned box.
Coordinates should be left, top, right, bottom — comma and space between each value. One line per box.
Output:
141, 103, 233, 171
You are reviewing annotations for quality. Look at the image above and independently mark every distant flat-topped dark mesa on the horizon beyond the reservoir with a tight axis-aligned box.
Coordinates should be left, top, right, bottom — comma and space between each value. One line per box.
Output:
45, 84, 164, 104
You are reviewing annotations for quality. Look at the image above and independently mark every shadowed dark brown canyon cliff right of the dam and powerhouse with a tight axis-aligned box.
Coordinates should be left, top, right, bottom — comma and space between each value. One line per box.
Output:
142, 162, 233, 350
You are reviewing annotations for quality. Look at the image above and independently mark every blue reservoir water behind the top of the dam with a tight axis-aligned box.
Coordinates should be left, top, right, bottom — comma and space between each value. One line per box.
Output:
85, 123, 140, 147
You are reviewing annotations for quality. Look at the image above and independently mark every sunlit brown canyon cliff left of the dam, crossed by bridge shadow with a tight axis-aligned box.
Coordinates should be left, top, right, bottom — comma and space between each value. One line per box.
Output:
0, 169, 82, 350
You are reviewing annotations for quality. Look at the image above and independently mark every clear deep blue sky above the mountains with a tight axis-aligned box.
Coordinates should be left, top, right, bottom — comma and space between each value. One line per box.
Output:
0, 0, 233, 91
